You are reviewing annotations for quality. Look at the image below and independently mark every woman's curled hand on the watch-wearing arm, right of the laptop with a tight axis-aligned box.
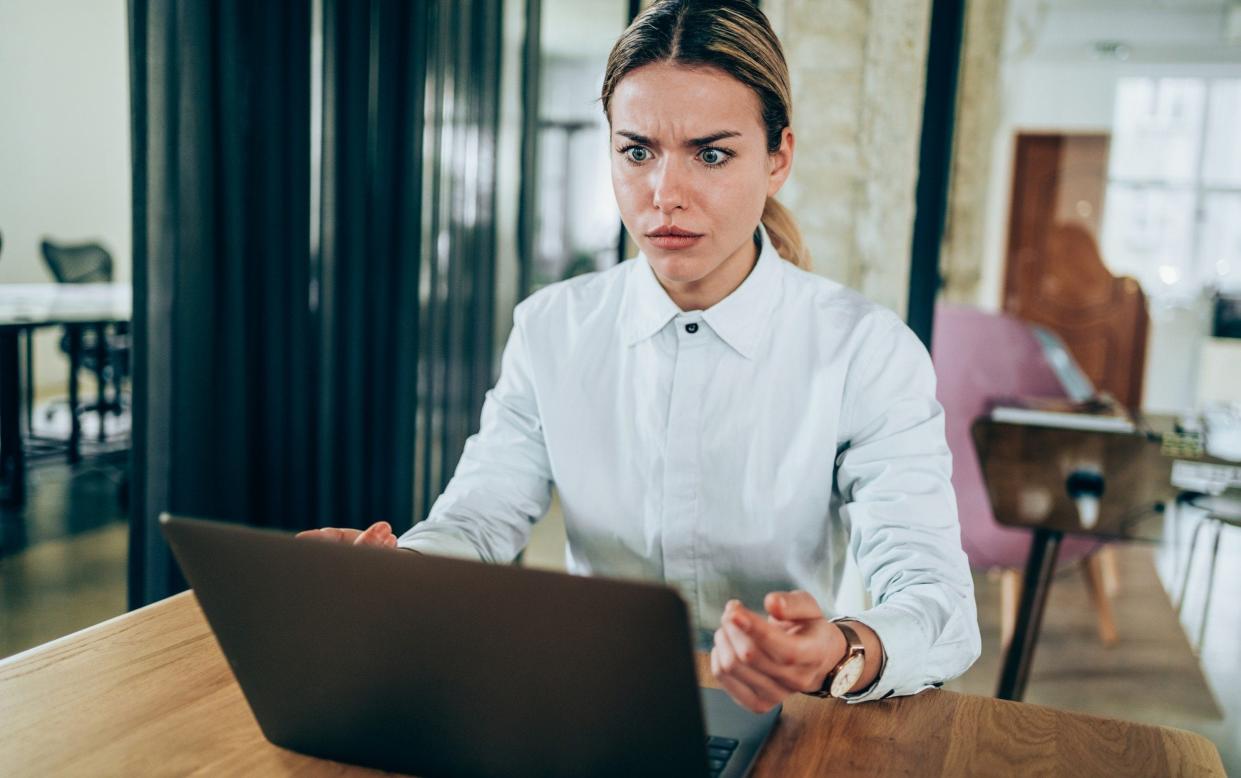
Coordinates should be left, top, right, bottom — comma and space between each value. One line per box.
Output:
711, 591, 848, 713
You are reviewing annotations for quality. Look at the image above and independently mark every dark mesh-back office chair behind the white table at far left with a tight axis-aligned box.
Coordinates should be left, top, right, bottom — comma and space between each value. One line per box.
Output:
41, 241, 129, 462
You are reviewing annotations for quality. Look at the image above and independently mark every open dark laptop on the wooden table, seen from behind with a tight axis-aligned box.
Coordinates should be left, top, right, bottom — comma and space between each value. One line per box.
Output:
160, 515, 779, 778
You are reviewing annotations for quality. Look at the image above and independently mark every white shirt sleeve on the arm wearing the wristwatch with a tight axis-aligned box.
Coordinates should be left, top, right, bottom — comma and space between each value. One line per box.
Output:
836, 316, 980, 702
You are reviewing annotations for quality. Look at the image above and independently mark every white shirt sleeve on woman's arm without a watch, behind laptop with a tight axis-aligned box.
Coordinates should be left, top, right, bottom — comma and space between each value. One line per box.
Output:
398, 305, 551, 562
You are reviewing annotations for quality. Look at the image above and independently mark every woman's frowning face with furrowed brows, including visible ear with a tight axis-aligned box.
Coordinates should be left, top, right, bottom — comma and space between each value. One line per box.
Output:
611, 63, 793, 294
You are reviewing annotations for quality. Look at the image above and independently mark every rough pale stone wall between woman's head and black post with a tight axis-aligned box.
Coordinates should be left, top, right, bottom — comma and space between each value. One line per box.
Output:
763, 0, 931, 316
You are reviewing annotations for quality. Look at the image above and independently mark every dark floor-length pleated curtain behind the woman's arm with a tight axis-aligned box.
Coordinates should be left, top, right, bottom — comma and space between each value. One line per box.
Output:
130, 0, 500, 607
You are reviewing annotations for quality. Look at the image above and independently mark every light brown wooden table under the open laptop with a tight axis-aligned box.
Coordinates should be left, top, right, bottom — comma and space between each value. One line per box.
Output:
0, 593, 1225, 778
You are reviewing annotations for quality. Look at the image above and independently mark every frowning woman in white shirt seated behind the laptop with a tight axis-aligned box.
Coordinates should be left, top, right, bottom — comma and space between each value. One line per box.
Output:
305, 0, 979, 711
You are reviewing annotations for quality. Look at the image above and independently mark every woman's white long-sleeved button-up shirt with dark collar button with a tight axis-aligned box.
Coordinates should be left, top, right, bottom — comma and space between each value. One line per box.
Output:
400, 228, 979, 699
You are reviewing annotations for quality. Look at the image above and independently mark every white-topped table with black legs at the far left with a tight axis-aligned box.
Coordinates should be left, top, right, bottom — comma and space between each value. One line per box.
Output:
0, 284, 133, 506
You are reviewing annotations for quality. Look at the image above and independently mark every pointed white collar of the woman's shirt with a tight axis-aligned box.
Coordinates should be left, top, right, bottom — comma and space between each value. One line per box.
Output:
621, 225, 782, 359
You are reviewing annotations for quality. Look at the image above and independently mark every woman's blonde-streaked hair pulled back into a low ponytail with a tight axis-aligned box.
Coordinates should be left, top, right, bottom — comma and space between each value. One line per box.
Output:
599, 0, 810, 269
